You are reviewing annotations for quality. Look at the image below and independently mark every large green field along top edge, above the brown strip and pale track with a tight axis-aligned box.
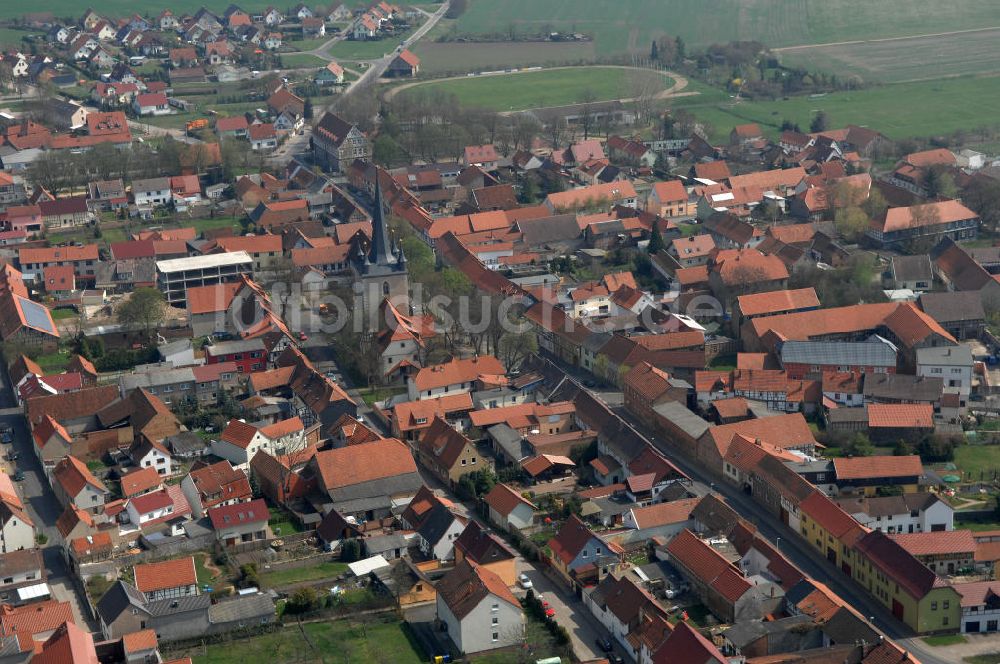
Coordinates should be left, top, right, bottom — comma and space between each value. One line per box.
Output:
457, 0, 1000, 55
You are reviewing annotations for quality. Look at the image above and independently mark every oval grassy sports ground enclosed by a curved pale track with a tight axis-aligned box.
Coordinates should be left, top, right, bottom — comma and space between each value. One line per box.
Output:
400, 67, 673, 111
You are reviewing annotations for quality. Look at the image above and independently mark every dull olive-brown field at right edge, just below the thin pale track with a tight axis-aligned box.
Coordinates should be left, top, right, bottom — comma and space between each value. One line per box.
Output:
778, 26, 1000, 82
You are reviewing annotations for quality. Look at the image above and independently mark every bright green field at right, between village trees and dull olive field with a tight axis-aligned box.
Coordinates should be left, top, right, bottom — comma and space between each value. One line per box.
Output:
672, 77, 1000, 143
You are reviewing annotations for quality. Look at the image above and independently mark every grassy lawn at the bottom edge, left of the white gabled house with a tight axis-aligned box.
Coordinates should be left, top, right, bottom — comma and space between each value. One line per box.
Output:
182, 620, 424, 664
